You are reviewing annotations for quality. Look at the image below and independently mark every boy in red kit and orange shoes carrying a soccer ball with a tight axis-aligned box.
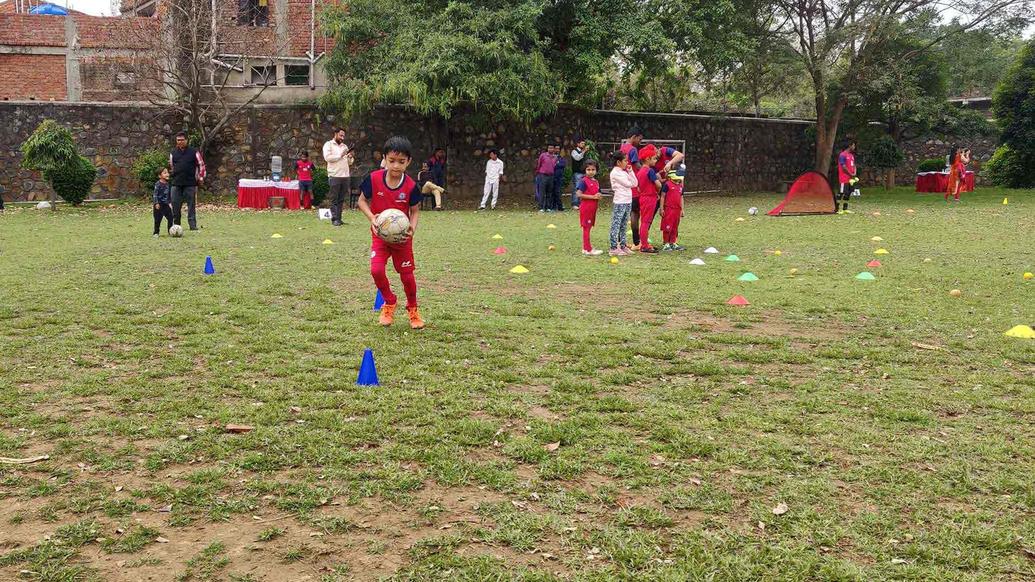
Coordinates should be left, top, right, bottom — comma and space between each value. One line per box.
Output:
358, 136, 424, 329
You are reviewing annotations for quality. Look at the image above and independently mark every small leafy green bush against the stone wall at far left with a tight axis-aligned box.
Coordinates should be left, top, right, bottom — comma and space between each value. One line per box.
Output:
21, 119, 97, 208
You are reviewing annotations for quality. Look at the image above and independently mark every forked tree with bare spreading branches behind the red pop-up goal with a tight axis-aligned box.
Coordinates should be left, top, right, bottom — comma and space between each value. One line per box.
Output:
774, 0, 1029, 174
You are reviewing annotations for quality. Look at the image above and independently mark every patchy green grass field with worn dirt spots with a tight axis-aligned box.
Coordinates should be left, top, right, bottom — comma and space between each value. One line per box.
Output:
0, 188, 1035, 581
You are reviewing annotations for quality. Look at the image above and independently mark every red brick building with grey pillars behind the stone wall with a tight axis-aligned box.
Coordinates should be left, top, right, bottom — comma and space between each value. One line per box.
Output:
0, 0, 333, 103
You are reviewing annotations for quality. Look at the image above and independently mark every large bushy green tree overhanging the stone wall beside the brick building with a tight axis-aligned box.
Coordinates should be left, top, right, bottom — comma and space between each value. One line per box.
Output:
322, 0, 562, 121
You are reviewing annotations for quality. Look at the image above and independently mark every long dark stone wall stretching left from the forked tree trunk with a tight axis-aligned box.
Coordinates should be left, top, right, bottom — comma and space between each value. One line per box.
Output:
0, 101, 812, 206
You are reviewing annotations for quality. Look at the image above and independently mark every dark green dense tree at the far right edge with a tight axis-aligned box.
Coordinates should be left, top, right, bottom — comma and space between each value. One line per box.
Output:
990, 39, 1035, 187
